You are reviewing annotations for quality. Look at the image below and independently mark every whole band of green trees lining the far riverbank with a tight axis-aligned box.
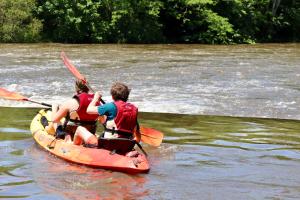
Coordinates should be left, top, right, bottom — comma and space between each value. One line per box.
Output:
0, 0, 300, 44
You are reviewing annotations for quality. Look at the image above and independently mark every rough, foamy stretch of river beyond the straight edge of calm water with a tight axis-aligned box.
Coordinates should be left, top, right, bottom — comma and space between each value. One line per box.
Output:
0, 45, 300, 118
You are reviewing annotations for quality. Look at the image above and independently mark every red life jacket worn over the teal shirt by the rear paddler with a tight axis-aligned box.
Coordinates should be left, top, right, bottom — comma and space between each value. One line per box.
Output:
114, 101, 138, 134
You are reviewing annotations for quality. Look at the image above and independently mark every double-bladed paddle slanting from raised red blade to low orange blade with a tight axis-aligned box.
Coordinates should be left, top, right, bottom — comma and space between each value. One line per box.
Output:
60, 51, 164, 147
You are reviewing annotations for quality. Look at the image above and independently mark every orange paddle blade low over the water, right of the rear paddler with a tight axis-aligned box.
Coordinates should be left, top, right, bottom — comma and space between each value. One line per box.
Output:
140, 126, 164, 147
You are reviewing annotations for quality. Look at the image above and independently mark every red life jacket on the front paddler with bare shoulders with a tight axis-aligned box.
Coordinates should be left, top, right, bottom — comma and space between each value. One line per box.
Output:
74, 93, 99, 121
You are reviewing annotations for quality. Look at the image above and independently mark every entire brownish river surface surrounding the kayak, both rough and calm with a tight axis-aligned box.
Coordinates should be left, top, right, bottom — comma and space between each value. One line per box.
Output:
0, 44, 300, 199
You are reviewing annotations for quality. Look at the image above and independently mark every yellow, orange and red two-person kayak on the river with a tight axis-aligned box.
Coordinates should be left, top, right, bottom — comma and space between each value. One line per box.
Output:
30, 109, 150, 174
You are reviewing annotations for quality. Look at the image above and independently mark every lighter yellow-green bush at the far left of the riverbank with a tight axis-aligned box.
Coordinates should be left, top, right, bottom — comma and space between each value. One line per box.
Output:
0, 0, 42, 42
